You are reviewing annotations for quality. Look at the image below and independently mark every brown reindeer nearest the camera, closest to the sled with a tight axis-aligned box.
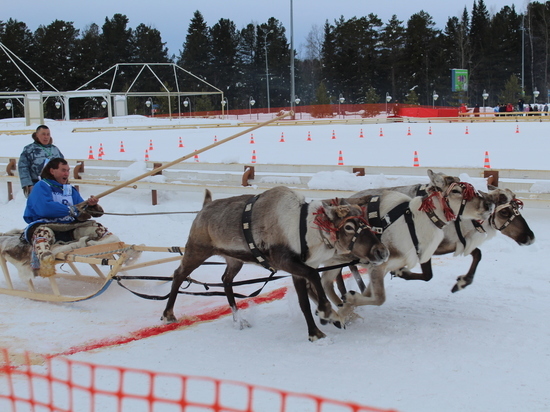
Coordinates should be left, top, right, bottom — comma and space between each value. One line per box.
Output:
161, 186, 389, 341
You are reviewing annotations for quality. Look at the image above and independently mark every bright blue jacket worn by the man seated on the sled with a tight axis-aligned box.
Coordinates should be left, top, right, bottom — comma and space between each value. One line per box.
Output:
23, 179, 84, 241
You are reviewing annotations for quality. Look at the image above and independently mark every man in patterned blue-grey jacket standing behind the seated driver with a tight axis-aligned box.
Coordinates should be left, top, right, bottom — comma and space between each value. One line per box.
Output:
17, 125, 64, 197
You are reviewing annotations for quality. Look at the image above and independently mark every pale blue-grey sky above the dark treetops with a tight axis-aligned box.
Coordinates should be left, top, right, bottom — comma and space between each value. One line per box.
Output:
4, 0, 532, 55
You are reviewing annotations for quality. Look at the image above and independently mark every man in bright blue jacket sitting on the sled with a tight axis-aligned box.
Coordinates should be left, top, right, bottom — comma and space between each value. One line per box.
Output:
23, 158, 111, 277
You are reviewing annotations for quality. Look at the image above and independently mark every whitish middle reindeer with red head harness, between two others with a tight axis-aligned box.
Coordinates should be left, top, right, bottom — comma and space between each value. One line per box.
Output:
314, 170, 494, 317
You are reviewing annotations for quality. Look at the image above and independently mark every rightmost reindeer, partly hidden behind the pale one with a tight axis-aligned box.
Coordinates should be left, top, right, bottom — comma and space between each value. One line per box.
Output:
394, 186, 535, 293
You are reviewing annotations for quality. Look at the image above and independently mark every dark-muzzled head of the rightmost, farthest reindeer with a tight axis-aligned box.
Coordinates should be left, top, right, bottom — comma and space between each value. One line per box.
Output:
487, 188, 535, 245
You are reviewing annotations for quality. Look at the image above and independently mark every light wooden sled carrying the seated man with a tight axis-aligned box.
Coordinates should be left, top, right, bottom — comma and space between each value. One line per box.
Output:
0, 242, 184, 302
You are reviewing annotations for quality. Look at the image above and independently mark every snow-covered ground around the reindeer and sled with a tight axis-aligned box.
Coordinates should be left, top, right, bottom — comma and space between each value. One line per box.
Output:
0, 116, 550, 412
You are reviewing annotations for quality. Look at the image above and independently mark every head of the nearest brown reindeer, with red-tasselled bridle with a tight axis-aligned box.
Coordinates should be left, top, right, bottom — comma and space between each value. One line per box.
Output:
315, 199, 390, 264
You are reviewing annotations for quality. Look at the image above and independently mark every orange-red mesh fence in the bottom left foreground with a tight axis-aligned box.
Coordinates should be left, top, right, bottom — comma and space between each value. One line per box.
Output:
0, 349, 395, 412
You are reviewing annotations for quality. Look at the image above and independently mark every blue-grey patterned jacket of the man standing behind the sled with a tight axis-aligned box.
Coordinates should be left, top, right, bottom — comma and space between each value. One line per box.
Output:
17, 141, 63, 187
